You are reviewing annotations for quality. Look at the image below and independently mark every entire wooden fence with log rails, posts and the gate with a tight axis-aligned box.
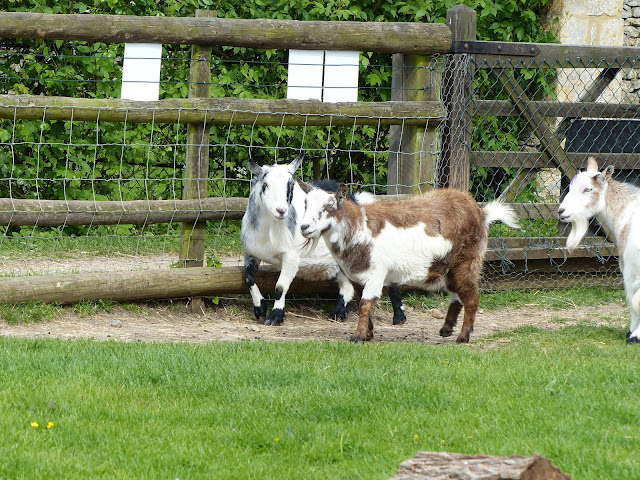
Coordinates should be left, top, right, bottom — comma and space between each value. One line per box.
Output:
0, 6, 640, 302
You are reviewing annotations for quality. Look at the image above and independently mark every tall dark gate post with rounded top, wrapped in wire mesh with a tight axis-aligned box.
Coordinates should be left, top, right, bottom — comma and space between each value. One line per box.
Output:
439, 5, 476, 192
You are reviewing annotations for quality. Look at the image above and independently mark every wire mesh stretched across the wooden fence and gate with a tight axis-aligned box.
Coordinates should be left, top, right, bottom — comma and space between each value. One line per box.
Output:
0, 29, 640, 289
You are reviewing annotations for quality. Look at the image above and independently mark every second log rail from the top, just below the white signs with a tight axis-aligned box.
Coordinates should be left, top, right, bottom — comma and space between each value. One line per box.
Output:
0, 95, 446, 127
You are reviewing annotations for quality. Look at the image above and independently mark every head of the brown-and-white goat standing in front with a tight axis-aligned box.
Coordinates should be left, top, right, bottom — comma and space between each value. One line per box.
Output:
300, 183, 347, 239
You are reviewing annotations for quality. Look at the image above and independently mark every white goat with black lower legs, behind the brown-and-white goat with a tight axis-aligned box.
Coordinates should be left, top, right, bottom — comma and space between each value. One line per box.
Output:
240, 153, 406, 325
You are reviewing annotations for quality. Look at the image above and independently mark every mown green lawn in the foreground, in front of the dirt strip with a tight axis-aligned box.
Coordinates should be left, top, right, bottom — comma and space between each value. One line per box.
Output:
0, 326, 640, 480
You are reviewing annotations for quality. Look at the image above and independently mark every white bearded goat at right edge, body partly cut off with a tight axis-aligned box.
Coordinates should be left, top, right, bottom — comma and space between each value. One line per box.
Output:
558, 157, 640, 343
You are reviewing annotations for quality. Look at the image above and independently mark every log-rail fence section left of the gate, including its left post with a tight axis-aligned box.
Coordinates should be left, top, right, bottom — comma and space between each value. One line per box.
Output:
0, 10, 451, 303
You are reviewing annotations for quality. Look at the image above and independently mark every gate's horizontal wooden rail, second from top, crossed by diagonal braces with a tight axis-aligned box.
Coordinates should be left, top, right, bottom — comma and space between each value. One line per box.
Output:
471, 100, 640, 119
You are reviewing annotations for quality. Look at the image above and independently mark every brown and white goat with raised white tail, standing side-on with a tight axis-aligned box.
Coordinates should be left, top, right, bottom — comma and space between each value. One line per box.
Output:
300, 185, 519, 343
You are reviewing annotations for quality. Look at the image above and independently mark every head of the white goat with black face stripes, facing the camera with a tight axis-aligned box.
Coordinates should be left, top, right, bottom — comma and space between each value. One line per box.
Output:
249, 152, 304, 220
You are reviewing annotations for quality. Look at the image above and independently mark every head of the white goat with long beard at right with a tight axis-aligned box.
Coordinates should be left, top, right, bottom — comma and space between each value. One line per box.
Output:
558, 157, 613, 249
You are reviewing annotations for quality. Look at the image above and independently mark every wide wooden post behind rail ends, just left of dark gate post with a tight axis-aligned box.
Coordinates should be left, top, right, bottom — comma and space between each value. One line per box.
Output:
387, 53, 441, 195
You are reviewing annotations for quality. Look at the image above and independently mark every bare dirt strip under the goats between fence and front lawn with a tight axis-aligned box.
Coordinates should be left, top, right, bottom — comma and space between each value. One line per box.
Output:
0, 300, 628, 344
